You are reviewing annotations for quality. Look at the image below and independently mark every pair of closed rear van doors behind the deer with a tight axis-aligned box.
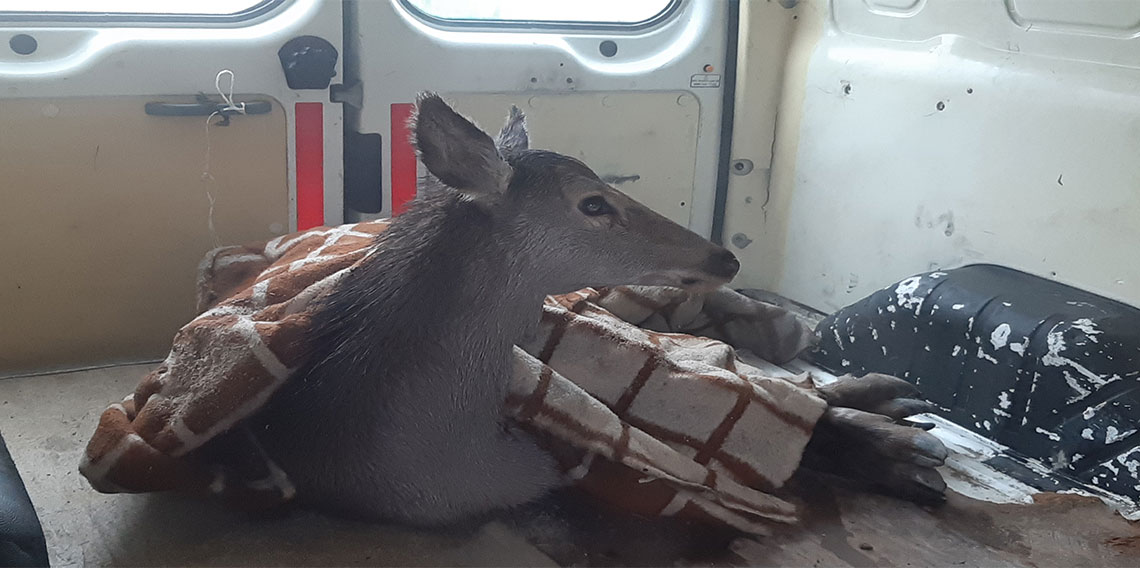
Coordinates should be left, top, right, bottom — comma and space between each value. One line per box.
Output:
0, 0, 736, 375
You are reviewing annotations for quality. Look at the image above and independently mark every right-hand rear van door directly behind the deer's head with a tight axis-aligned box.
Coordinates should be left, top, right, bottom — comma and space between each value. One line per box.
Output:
345, 0, 735, 236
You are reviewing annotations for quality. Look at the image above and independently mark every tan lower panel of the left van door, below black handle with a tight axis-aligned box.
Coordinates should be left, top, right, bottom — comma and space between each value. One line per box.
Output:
0, 97, 288, 375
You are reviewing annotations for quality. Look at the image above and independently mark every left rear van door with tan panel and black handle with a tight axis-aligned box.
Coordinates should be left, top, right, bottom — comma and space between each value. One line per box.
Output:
0, 0, 342, 375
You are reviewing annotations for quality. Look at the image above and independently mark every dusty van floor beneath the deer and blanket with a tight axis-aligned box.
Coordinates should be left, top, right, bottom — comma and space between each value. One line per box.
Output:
0, 366, 1140, 567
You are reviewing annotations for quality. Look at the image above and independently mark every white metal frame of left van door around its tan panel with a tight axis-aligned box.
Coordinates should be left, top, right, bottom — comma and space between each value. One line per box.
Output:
0, 0, 343, 230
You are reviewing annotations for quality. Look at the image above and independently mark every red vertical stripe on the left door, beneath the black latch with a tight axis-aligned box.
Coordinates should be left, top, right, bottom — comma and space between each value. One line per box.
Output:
294, 103, 325, 230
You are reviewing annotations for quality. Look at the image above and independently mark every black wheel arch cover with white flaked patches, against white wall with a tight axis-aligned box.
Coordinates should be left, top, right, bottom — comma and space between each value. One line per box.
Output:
813, 265, 1140, 502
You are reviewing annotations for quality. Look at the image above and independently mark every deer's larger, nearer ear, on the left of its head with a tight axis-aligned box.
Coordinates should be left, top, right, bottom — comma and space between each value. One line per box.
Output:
412, 92, 511, 200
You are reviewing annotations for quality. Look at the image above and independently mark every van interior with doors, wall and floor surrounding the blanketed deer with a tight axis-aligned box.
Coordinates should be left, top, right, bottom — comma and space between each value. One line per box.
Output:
0, 0, 1140, 567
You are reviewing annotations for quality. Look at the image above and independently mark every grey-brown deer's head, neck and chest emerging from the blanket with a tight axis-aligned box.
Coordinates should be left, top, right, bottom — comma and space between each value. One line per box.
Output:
253, 94, 740, 525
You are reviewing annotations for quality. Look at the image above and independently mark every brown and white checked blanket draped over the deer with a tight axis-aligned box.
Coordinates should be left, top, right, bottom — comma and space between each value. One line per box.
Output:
80, 221, 827, 534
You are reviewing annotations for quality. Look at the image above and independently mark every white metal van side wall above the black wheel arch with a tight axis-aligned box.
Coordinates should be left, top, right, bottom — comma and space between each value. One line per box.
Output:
726, 0, 1140, 310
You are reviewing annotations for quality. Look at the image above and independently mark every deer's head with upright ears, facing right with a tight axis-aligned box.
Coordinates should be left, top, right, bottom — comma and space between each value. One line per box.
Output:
413, 94, 740, 293
